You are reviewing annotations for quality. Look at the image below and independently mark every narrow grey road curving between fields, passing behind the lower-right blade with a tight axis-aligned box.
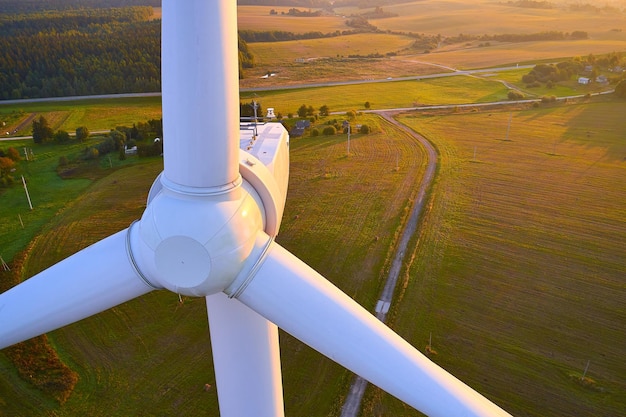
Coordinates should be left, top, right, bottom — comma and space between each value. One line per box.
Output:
341, 111, 437, 417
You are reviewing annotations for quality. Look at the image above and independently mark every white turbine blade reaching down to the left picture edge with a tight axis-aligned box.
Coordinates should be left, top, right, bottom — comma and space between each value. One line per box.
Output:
0, 230, 153, 349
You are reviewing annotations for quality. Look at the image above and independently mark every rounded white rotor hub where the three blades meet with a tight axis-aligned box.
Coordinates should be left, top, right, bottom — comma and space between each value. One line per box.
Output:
130, 176, 265, 296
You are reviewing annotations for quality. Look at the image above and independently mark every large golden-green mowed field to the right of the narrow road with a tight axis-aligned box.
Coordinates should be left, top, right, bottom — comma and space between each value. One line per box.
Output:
356, 101, 626, 417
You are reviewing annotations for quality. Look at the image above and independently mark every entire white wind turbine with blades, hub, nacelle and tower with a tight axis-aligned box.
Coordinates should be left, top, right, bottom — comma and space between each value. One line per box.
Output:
0, 0, 508, 417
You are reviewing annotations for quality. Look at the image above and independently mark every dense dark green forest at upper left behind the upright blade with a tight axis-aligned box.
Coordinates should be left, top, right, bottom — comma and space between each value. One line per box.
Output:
0, 0, 254, 100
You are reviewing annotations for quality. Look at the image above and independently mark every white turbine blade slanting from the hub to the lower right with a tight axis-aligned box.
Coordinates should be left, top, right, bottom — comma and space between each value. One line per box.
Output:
232, 244, 509, 417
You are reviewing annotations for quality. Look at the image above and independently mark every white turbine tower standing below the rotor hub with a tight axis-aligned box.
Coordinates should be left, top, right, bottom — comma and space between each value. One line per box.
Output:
206, 293, 284, 417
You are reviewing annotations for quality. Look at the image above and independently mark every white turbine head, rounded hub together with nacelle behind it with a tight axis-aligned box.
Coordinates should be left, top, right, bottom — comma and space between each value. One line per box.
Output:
129, 123, 289, 297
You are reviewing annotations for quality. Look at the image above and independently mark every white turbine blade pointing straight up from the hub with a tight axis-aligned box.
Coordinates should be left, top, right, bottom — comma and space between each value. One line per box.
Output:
161, 0, 239, 188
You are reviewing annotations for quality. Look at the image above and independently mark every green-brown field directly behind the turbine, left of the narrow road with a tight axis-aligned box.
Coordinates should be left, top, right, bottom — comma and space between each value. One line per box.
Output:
0, 116, 424, 416
